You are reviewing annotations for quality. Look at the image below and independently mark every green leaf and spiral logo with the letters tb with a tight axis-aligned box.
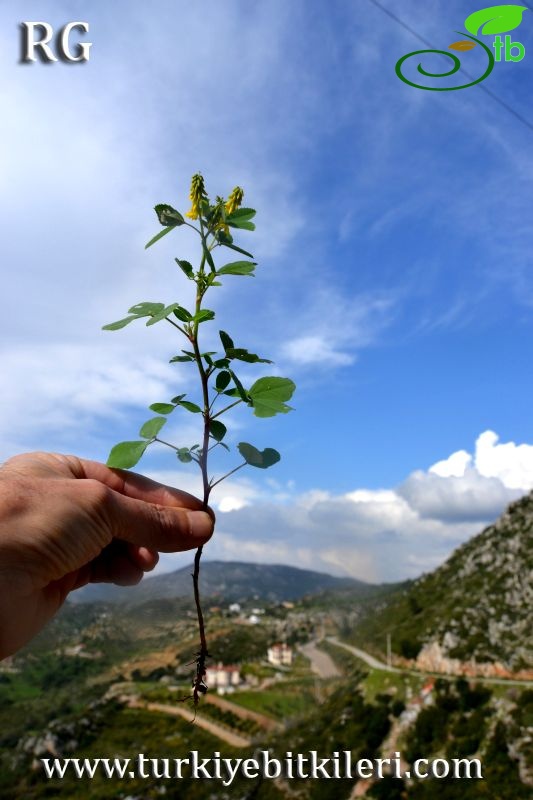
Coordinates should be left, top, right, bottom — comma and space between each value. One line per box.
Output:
396, 5, 527, 92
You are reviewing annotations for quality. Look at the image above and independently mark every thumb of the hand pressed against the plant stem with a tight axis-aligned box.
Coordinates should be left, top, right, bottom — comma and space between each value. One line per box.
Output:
108, 491, 215, 553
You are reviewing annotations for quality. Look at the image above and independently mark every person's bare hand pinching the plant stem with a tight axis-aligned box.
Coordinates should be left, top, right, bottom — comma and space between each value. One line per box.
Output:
0, 453, 214, 658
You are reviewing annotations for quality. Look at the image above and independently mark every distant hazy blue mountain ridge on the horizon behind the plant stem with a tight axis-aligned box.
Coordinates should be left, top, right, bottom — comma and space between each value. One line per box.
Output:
70, 561, 371, 605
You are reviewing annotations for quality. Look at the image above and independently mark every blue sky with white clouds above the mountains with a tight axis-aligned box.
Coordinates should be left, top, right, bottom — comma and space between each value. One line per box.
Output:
0, 0, 533, 581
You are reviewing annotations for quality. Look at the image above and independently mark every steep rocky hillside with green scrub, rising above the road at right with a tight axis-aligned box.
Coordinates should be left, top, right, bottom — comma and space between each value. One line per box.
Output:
353, 493, 533, 677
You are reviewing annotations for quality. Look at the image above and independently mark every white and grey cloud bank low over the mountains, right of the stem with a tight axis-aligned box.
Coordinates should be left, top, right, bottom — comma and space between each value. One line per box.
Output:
153, 431, 533, 582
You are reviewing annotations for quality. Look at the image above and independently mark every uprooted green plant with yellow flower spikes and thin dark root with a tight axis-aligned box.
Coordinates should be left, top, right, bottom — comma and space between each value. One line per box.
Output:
100, 174, 295, 708
